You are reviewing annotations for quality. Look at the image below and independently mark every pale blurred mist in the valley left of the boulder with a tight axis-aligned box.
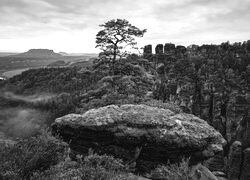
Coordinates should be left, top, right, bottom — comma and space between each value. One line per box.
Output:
0, 92, 59, 138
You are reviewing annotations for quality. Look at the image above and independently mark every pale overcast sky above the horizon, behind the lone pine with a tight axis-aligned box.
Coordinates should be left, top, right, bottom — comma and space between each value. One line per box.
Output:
0, 0, 250, 53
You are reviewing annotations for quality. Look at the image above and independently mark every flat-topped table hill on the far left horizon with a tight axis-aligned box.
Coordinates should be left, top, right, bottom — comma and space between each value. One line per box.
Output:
12, 49, 62, 58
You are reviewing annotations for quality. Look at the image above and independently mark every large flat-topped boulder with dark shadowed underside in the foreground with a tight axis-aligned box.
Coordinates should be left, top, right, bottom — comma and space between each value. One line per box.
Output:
52, 104, 226, 172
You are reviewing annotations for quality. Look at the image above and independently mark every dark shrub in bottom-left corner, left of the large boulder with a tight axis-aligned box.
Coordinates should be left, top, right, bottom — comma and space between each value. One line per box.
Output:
0, 131, 67, 179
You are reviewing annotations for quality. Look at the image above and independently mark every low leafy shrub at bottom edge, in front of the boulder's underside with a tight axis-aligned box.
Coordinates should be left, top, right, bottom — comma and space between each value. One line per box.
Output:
31, 154, 138, 180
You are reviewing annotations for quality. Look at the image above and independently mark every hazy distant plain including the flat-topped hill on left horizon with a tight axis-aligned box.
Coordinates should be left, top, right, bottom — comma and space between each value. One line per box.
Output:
0, 49, 97, 78
